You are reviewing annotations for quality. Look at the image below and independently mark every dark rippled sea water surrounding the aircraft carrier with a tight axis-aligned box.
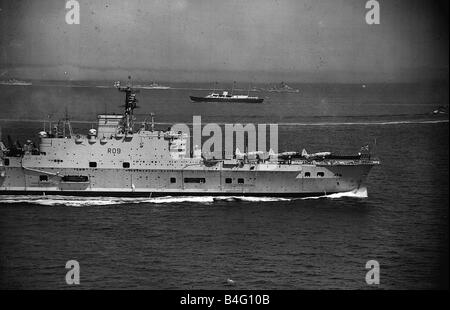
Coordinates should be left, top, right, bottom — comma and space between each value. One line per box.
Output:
0, 81, 449, 289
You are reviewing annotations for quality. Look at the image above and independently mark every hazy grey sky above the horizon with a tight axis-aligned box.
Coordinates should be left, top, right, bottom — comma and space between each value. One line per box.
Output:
0, 0, 449, 83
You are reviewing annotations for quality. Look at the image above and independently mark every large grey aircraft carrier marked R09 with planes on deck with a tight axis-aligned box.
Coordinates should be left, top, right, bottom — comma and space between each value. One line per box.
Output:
0, 80, 379, 197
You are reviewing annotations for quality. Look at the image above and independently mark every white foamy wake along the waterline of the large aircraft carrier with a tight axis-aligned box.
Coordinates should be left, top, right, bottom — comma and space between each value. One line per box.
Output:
0, 188, 367, 207
